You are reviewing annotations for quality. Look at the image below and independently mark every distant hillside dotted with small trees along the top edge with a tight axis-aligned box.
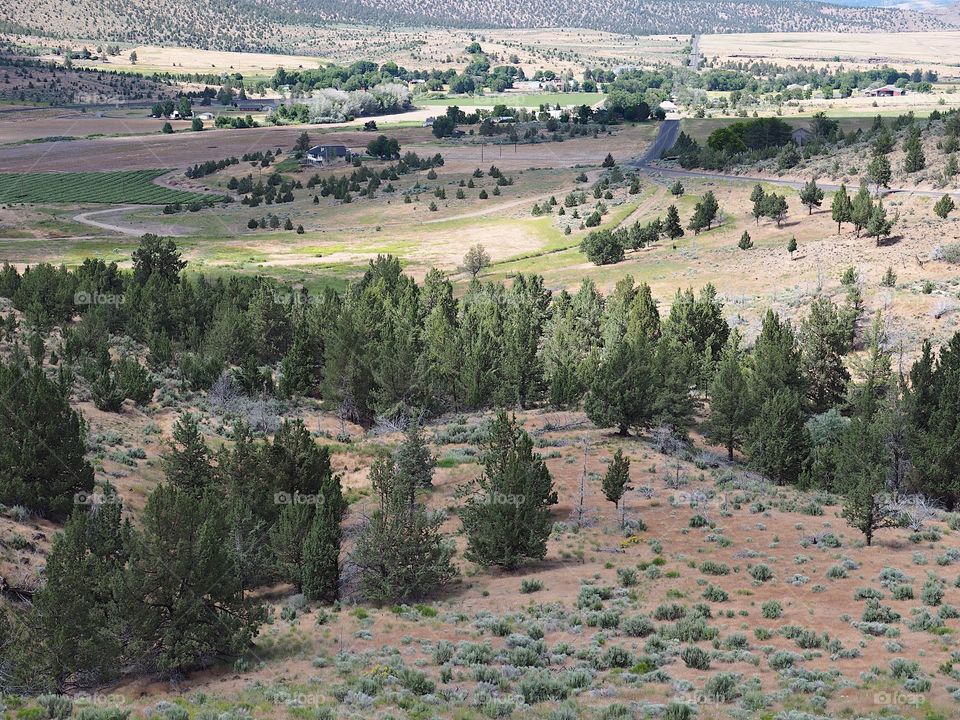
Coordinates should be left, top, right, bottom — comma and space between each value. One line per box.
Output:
0, 0, 944, 51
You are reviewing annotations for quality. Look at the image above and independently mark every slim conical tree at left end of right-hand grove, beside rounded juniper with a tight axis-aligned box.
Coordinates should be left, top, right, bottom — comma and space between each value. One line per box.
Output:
707, 335, 754, 460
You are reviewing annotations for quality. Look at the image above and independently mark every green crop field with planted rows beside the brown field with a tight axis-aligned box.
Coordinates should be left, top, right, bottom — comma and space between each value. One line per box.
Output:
0, 170, 221, 205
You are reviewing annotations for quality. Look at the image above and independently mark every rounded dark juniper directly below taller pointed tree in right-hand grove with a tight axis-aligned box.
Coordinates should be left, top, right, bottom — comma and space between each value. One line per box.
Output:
745, 390, 809, 485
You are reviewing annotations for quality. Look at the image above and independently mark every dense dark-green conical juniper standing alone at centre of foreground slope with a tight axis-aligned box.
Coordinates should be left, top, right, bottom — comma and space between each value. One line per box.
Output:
460, 411, 557, 570
